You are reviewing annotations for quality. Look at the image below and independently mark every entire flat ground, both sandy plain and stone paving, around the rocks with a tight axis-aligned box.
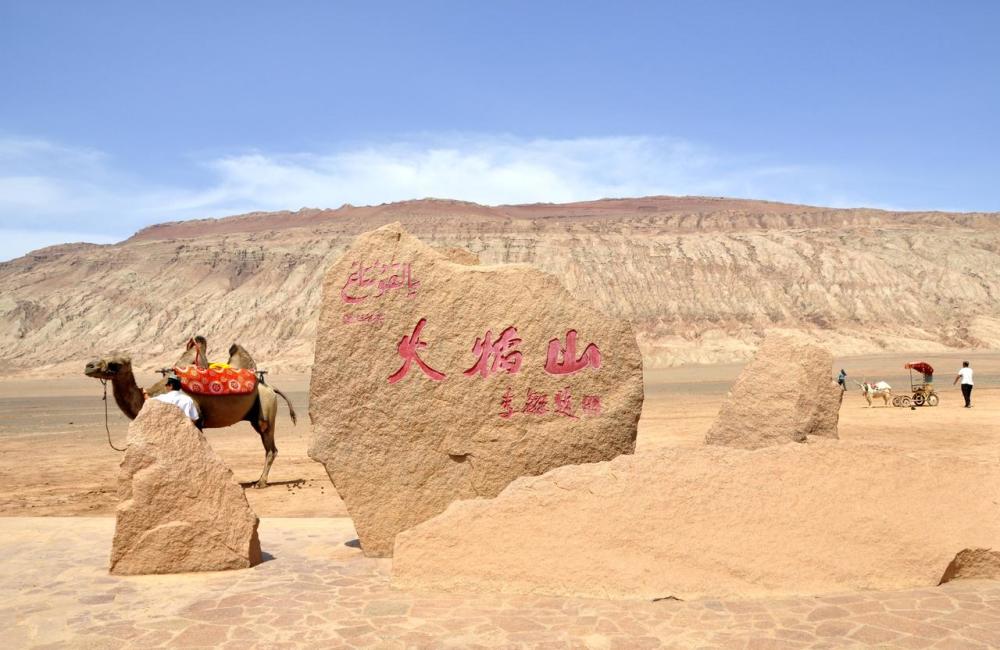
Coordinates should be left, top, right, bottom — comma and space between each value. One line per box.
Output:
0, 351, 1000, 648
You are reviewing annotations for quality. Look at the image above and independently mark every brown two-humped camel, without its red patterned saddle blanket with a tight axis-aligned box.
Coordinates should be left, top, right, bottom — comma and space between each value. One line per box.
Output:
83, 337, 297, 488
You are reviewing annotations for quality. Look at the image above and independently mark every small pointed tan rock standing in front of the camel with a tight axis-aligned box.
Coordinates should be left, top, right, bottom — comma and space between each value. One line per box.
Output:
111, 400, 261, 575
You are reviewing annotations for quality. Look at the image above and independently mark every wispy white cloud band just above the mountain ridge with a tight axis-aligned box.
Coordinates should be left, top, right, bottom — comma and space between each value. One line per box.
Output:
0, 134, 884, 259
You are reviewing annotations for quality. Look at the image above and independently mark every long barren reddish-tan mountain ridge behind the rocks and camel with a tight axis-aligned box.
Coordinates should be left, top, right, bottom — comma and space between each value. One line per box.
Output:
0, 197, 1000, 372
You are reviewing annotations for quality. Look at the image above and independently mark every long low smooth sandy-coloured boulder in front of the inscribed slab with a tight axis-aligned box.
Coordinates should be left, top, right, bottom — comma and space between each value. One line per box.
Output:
392, 440, 1000, 599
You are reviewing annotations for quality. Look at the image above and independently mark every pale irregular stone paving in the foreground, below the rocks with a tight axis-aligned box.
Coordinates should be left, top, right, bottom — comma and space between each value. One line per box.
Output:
0, 518, 1000, 650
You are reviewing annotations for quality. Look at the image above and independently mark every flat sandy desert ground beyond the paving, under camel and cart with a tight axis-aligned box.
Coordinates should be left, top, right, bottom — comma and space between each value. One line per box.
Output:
0, 353, 1000, 517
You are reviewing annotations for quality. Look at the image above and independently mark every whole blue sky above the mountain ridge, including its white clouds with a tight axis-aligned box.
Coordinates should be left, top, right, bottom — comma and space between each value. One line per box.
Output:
0, 0, 1000, 259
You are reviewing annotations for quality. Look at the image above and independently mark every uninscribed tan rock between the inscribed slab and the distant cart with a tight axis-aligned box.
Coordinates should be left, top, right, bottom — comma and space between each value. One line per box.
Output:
705, 334, 844, 449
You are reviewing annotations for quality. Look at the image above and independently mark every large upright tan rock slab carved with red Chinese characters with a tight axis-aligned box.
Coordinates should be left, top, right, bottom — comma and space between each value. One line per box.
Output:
309, 224, 643, 556
